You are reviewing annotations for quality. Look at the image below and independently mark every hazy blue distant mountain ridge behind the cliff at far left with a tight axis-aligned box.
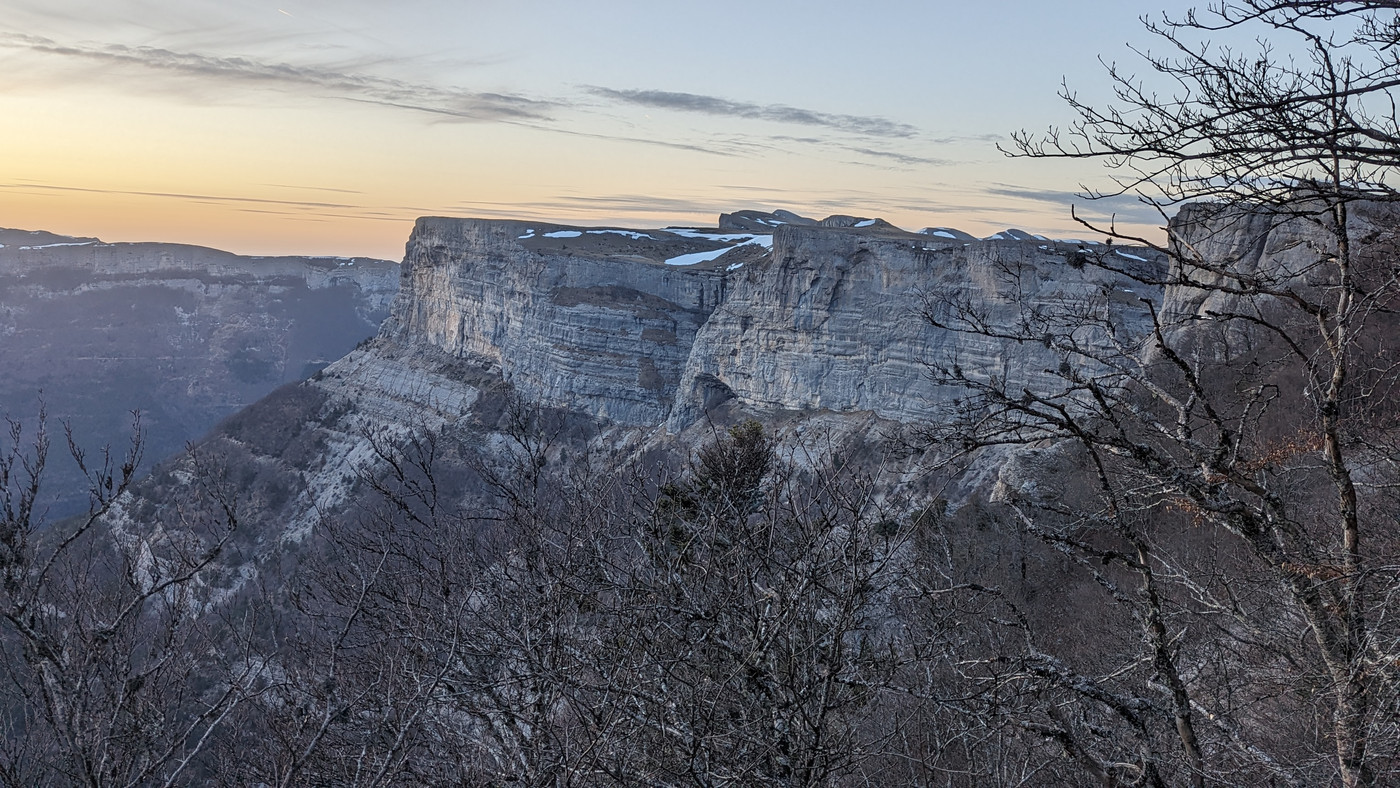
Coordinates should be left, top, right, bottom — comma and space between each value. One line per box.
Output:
0, 230, 399, 516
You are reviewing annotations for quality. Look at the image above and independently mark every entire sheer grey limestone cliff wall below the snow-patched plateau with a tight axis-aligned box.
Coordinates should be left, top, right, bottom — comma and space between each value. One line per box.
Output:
357, 218, 1155, 432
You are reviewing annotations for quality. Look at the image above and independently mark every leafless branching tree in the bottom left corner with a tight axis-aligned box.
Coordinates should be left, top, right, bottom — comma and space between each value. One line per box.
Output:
0, 407, 248, 787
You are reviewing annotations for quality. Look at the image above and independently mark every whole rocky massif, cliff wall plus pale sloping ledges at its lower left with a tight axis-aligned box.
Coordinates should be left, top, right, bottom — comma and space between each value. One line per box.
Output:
109, 208, 1159, 579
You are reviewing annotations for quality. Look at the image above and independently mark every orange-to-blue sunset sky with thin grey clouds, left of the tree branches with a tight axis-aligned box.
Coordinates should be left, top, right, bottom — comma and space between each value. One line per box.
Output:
0, 0, 1189, 260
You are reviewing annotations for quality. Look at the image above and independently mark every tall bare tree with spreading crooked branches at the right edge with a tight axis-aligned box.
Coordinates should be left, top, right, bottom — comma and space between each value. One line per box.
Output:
927, 0, 1400, 787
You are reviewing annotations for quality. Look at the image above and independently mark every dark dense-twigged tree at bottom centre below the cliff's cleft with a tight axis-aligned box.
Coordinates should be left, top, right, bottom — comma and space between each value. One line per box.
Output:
596, 421, 904, 787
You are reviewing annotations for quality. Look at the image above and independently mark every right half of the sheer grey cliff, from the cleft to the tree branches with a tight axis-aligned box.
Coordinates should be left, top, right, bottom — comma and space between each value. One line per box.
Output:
668, 227, 1147, 431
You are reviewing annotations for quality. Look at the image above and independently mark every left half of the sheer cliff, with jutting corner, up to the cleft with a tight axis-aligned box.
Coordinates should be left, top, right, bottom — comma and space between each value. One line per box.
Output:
385, 218, 725, 424
